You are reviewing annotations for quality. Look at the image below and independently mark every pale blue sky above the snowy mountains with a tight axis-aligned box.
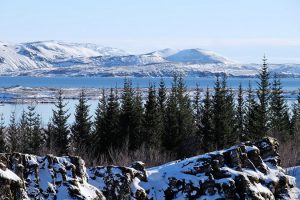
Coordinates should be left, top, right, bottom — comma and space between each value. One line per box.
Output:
0, 0, 300, 63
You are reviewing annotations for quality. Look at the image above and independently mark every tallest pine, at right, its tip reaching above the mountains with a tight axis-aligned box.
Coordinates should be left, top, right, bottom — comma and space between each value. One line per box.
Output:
255, 56, 270, 138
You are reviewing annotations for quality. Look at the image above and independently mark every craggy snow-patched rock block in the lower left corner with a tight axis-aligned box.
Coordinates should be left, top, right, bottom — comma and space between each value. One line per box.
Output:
0, 153, 105, 200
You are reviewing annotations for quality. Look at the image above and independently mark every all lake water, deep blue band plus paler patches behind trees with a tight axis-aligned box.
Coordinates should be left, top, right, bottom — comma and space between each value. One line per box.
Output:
0, 77, 300, 125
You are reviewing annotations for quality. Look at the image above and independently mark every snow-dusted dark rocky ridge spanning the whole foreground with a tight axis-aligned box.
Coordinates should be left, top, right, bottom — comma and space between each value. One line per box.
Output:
0, 138, 295, 200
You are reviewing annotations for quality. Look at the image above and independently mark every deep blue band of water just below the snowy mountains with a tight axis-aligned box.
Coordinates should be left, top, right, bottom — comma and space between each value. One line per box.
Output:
0, 76, 300, 90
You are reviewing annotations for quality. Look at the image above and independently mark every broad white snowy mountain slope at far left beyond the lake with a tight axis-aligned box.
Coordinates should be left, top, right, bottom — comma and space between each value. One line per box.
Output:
0, 41, 127, 72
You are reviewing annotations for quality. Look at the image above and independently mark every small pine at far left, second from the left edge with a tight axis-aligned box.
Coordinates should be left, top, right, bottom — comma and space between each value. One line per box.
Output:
7, 112, 20, 152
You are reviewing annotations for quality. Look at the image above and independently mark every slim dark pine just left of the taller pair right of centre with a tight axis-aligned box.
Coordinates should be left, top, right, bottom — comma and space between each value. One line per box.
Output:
200, 88, 215, 152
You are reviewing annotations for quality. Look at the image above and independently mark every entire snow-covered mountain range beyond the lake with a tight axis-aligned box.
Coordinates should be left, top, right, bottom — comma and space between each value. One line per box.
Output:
0, 41, 300, 76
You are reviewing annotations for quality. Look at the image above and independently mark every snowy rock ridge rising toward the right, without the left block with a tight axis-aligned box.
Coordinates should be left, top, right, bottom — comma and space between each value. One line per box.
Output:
88, 138, 294, 200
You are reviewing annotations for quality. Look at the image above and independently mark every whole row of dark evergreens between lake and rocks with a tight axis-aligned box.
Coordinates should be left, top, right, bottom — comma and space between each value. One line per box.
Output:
0, 59, 300, 163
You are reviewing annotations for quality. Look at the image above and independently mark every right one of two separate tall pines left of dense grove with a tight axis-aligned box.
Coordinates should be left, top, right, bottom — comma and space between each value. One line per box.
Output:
71, 90, 92, 154
